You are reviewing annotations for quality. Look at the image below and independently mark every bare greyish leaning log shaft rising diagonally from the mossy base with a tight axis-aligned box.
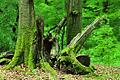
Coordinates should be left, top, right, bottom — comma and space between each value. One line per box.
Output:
61, 17, 105, 53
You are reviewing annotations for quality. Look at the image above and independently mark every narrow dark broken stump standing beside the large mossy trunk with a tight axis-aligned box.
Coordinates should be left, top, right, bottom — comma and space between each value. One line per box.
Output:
35, 16, 44, 63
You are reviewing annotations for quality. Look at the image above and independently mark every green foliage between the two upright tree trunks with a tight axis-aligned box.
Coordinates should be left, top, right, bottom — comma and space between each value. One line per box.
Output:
35, 0, 65, 34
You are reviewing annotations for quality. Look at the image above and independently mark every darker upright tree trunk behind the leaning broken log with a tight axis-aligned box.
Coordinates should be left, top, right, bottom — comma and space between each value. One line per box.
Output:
65, 0, 82, 44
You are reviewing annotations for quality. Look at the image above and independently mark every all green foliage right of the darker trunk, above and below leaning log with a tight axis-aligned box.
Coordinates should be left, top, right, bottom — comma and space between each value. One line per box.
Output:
81, 0, 120, 66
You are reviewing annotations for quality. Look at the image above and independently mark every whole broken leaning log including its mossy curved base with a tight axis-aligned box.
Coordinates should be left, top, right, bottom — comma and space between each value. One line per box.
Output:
58, 17, 104, 74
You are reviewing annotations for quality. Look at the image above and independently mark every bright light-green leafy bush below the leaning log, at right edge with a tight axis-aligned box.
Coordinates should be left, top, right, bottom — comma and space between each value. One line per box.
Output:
81, 25, 120, 65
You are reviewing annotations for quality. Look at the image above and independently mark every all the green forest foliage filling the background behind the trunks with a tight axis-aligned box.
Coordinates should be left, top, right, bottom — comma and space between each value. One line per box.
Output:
0, 0, 120, 68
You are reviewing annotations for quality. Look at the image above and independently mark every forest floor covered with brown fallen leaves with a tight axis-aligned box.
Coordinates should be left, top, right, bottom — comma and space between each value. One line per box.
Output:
0, 65, 120, 80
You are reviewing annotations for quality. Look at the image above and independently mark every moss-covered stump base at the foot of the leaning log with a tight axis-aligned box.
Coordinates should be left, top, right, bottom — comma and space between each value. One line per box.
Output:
58, 48, 94, 74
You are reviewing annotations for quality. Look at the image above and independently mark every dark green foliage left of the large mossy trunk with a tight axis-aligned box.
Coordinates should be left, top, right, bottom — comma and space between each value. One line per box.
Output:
0, 0, 18, 51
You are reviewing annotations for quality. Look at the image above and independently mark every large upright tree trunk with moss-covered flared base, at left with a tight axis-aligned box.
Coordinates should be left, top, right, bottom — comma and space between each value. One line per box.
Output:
6, 0, 35, 69
